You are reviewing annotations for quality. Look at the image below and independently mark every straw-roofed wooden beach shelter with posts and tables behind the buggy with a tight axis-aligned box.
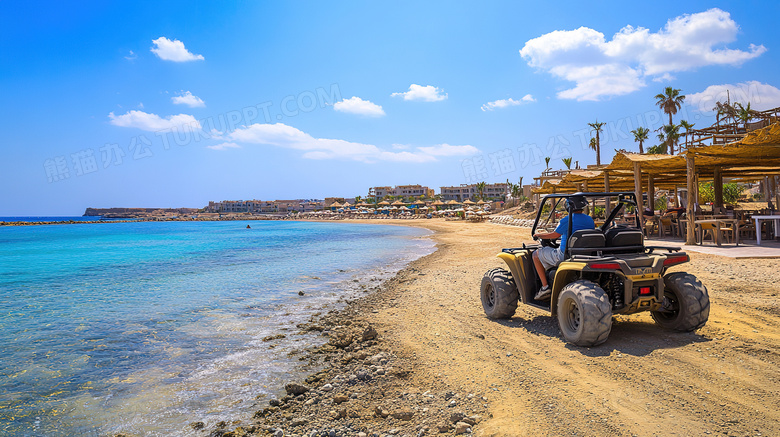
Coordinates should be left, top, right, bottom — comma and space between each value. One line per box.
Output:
534, 108, 780, 246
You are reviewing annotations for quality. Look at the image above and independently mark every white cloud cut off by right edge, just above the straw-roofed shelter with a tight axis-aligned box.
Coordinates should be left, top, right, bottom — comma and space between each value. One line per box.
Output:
685, 80, 780, 112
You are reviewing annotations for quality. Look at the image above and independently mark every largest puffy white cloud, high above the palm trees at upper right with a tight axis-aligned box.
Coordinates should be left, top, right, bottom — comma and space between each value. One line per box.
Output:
520, 8, 766, 100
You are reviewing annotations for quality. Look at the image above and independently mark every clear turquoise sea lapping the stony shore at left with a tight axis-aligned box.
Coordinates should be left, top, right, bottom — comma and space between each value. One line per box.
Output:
0, 221, 434, 436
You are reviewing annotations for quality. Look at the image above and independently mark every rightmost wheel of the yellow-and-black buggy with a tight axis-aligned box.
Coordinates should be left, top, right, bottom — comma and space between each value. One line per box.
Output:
651, 272, 710, 332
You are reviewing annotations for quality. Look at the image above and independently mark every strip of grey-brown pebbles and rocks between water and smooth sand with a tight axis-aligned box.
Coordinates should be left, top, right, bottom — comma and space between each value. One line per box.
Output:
180, 255, 488, 437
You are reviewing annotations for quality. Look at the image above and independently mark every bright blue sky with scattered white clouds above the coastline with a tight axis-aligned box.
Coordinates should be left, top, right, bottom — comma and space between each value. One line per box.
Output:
0, 1, 780, 216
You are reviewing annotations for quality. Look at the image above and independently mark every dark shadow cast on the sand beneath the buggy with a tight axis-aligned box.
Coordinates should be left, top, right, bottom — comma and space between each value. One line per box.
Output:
494, 315, 711, 357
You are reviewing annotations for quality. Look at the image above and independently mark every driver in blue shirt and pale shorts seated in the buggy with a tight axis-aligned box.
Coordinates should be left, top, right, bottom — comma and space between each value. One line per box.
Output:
533, 196, 596, 300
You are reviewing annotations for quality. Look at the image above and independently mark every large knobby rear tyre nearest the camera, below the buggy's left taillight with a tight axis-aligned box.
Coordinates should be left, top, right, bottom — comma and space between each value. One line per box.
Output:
556, 280, 612, 346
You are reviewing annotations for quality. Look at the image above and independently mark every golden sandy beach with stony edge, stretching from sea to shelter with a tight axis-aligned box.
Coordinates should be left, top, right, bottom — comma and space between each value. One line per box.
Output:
200, 220, 780, 437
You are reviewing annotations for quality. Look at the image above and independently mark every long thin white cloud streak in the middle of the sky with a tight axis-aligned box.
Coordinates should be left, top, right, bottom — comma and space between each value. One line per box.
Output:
230, 123, 479, 163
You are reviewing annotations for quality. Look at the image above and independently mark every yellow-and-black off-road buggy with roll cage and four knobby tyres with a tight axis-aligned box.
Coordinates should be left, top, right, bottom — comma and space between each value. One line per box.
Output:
480, 192, 710, 346
